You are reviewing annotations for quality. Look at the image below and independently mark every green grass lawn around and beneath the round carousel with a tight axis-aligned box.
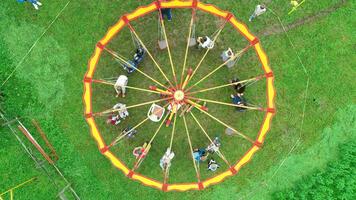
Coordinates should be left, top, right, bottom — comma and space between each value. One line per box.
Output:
0, 0, 356, 199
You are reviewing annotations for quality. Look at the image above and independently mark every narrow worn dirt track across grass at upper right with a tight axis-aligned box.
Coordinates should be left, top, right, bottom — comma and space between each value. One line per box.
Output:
258, 0, 347, 36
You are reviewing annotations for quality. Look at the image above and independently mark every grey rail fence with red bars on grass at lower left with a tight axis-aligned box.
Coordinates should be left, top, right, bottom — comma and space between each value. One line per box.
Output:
0, 112, 80, 200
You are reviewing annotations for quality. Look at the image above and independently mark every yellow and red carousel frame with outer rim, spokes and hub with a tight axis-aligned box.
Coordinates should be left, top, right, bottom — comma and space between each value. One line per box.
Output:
83, 0, 276, 191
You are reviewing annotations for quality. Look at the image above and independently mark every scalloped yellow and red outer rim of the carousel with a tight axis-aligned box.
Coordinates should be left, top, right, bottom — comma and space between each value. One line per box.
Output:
83, 0, 276, 191
